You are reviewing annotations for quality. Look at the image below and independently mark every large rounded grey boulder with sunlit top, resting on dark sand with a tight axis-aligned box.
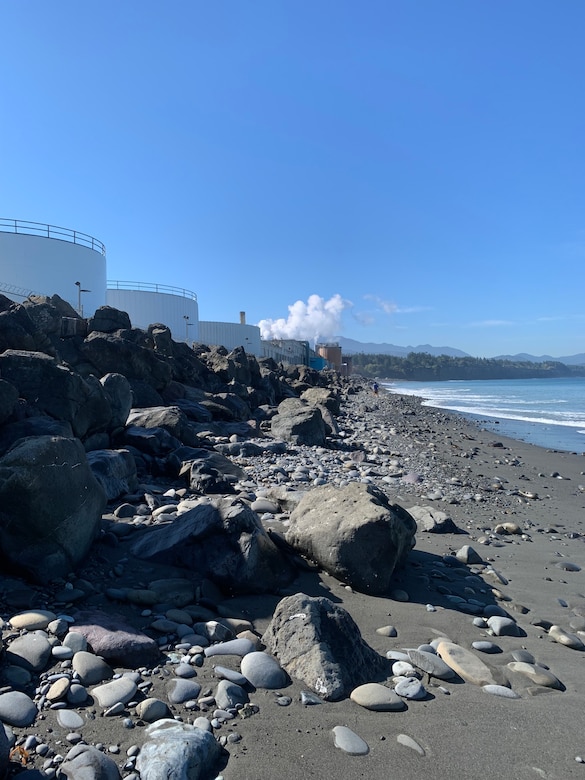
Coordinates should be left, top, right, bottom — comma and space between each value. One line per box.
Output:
286, 482, 416, 596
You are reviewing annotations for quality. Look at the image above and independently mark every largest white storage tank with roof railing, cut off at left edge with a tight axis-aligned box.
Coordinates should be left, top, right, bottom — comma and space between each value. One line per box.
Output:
0, 218, 107, 317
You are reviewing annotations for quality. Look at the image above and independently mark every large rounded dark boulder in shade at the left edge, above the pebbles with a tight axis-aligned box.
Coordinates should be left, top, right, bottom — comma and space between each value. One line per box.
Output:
0, 436, 106, 583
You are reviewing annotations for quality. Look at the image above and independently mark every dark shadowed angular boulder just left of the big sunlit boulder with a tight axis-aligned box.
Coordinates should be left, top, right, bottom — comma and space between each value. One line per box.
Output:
131, 498, 296, 594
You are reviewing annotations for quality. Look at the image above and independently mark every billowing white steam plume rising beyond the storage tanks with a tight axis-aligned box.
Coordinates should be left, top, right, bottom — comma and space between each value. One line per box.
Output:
258, 293, 352, 343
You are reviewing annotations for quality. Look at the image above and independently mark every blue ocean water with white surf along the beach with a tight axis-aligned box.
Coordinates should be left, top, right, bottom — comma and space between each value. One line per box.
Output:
381, 377, 585, 452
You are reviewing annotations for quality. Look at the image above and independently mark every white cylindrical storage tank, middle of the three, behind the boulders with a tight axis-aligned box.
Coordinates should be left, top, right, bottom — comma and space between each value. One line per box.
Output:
106, 281, 200, 342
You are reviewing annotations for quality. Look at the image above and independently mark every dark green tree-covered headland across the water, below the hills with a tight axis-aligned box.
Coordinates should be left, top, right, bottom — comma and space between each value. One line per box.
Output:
351, 352, 585, 382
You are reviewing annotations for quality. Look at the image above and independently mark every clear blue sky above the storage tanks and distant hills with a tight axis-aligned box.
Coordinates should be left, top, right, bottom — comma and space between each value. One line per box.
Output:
0, 0, 585, 356
